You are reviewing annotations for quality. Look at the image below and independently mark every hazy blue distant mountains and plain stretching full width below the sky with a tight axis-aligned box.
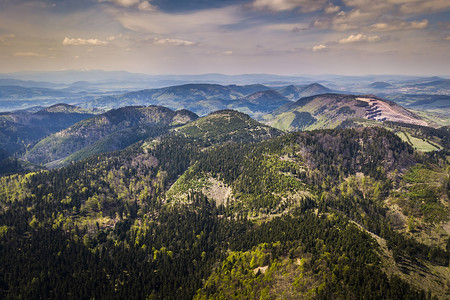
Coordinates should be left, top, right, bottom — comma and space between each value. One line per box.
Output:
0, 70, 450, 118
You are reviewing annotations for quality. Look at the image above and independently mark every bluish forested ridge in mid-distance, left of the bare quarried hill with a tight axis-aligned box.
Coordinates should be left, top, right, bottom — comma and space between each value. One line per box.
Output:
81, 83, 340, 118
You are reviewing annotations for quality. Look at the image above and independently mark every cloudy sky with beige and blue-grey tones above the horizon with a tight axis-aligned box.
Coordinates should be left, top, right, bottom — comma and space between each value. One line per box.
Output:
0, 0, 450, 75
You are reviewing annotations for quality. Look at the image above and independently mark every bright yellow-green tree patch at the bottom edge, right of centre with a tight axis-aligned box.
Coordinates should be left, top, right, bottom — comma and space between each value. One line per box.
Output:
194, 242, 319, 300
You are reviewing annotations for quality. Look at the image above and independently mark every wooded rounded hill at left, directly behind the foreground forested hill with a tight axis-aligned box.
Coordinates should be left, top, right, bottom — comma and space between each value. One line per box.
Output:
24, 106, 197, 165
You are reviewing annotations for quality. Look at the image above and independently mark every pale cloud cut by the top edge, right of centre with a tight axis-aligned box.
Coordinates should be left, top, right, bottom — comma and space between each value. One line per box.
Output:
252, 0, 327, 13
